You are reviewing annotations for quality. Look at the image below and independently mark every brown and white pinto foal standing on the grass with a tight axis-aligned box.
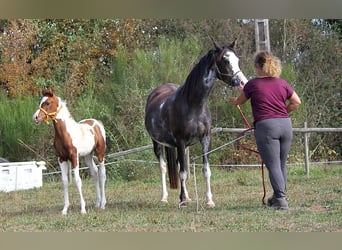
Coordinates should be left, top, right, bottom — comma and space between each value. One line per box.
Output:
32, 87, 106, 215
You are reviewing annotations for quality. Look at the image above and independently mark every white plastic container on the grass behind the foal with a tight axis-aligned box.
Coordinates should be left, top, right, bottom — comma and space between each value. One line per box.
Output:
0, 161, 46, 192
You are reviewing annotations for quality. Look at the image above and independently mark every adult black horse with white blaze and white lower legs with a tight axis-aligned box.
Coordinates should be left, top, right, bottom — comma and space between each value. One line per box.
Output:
145, 41, 247, 207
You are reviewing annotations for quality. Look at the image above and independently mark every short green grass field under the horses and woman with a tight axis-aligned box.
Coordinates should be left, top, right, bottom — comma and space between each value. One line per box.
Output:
0, 165, 342, 232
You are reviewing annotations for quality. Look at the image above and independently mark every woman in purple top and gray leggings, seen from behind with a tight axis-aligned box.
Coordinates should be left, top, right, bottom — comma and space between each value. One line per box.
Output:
229, 51, 301, 210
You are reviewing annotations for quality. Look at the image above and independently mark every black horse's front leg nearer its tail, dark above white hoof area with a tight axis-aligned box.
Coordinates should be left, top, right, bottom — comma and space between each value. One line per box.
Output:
177, 144, 191, 207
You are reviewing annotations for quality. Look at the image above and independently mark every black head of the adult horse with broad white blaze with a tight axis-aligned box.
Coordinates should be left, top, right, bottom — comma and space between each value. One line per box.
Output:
213, 39, 247, 87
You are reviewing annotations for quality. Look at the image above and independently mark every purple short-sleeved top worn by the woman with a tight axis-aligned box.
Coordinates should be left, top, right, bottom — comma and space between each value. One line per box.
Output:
243, 77, 294, 124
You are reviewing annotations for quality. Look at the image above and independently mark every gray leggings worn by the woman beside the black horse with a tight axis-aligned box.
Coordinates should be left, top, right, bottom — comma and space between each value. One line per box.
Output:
254, 118, 292, 198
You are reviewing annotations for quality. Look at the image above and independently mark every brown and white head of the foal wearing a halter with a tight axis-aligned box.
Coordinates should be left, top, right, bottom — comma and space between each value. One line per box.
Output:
32, 87, 60, 124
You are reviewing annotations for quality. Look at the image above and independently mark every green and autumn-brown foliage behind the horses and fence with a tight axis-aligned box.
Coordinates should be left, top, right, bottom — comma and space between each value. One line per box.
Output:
0, 19, 342, 178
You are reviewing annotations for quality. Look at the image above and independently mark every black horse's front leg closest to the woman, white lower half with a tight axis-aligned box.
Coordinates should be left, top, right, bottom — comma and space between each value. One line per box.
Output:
202, 136, 215, 207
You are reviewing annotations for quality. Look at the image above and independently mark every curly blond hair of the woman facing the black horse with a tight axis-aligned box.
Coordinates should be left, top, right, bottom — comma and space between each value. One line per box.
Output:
254, 51, 282, 77
